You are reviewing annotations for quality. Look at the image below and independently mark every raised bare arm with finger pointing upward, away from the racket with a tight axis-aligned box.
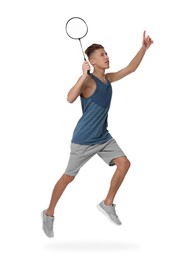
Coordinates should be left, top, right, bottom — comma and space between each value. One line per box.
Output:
106, 31, 153, 82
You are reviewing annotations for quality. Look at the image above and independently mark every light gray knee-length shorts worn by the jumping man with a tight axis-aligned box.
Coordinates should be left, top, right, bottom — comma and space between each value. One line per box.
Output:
65, 138, 126, 176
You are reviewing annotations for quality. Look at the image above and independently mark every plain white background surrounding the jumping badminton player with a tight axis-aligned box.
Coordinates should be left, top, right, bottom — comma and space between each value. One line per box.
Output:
0, 0, 183, 260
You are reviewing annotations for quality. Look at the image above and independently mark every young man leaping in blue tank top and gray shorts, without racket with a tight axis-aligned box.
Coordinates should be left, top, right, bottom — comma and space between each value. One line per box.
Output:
42, 31, 153, 237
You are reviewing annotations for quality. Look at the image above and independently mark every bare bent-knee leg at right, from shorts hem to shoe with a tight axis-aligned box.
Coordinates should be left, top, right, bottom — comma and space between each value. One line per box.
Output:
104, 156, 130, 206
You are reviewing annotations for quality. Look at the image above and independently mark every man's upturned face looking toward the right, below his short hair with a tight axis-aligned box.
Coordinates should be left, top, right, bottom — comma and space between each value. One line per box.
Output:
90, 49, 109, 69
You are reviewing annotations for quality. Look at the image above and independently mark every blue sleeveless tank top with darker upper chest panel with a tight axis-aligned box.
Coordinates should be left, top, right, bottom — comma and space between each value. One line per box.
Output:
71, 74, 112, 145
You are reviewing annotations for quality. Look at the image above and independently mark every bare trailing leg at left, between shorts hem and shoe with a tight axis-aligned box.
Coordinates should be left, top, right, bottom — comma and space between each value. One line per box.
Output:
46, 174, 75, 216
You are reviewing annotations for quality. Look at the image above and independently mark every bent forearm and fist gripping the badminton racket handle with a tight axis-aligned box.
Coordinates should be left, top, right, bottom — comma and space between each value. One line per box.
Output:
67, 61, 90, 103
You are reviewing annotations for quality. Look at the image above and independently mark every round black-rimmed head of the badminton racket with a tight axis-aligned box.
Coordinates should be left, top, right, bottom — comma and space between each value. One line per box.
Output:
65, 16, 88, 40
